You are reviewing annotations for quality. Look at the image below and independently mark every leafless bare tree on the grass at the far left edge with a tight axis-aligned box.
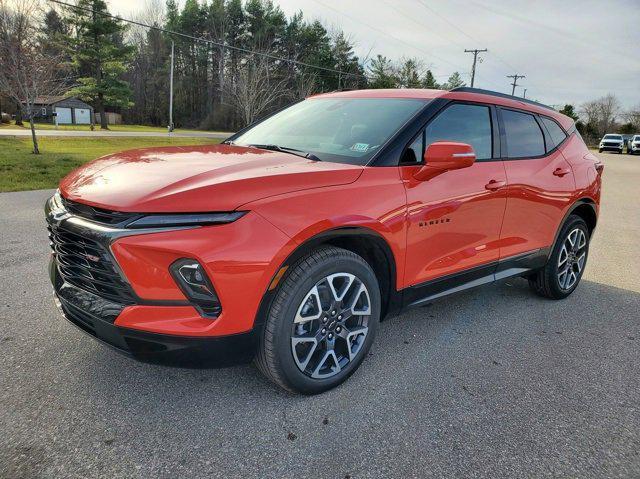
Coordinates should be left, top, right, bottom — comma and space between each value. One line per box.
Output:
0, 0, 67, 155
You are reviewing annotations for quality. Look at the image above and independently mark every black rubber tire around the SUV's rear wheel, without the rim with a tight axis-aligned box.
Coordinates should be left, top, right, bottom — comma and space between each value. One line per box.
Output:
528, 215, 590, 299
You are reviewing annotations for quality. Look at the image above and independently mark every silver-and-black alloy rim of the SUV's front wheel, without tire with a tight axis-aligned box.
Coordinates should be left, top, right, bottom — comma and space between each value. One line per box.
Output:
291, 272, 371, 379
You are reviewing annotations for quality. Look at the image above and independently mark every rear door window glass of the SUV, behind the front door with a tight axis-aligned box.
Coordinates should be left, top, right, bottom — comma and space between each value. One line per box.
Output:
502, 110, 545, 158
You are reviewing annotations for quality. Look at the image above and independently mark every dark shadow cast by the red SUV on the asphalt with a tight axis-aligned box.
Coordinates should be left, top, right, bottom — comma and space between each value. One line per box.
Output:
76, 278, 640, 402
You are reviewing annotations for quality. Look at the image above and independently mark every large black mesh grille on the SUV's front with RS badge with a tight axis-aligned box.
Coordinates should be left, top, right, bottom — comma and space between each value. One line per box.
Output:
48, 226, 135, 304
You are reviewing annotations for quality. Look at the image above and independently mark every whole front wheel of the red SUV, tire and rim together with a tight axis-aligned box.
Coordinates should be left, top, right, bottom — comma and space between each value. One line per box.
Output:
256, 246, 381, 394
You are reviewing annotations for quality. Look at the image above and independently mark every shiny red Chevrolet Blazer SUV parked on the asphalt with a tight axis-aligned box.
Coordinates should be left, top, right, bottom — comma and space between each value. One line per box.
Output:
46, 88, 602, 394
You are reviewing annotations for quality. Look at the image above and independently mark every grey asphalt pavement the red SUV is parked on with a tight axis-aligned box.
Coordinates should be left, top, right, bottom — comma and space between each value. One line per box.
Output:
0, 155, 640, 479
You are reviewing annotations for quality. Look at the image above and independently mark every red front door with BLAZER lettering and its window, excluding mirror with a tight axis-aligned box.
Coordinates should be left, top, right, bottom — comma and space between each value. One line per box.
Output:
400, 103, 507, 286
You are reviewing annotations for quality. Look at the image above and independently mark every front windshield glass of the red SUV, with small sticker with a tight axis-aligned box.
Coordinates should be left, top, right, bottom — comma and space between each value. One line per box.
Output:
232, 98, 426, 165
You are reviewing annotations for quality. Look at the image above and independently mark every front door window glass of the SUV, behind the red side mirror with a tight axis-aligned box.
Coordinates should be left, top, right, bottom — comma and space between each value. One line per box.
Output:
426, 104, 493, 160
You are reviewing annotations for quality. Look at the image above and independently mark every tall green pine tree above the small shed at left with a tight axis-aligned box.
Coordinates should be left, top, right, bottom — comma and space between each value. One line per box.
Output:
70, 0, 133, 130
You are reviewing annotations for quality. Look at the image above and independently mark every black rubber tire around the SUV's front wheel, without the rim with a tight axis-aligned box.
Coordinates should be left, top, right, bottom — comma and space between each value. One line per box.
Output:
255, 246, 382, 394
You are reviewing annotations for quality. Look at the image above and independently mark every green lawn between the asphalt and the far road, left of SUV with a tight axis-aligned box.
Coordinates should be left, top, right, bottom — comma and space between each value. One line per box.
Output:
0, 137, 219, 192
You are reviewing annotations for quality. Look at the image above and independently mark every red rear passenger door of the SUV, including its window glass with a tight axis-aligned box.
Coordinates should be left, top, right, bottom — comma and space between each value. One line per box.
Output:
498, 108, 575, 259
